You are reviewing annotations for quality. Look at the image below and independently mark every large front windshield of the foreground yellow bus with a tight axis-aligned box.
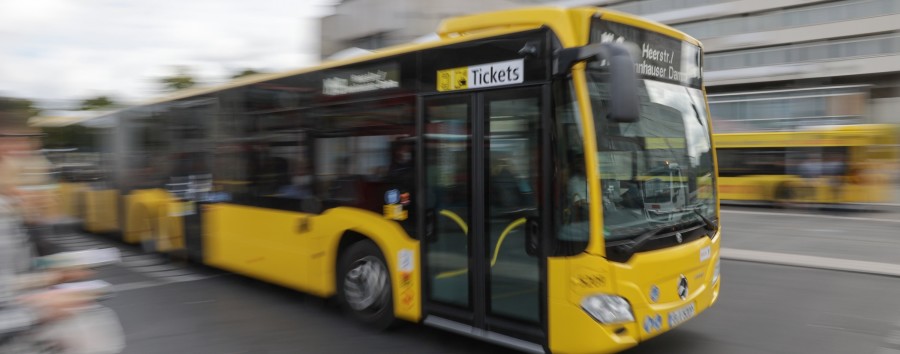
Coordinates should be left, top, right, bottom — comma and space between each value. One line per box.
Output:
587, 74, 715, 240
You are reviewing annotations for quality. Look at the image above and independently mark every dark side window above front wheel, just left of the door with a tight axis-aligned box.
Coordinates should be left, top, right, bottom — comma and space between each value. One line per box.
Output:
313, 97, 415, 214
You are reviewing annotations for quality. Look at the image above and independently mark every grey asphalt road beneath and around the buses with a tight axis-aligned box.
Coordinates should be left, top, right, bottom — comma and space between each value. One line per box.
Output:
44, 208, 900, 354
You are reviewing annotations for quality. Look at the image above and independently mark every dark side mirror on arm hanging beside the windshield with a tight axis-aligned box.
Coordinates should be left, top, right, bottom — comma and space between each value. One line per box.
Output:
553, 43, 640, 123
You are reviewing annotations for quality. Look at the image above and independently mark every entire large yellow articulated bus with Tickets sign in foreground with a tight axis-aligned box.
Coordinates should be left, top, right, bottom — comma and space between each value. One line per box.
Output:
51, 7, 721, 353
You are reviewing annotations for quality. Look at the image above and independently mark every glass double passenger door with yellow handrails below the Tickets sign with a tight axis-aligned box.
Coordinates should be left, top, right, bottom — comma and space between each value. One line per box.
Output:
423, 87, 545, 346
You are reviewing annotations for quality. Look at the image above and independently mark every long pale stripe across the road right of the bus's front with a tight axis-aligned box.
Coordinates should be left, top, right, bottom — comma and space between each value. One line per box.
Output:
720, 248, 900, 277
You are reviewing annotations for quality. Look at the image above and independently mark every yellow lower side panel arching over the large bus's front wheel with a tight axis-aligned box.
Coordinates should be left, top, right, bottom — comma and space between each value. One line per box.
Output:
203, 204, 421, 322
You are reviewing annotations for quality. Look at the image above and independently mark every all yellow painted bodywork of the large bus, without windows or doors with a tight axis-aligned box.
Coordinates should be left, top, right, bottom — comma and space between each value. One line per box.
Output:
67, 7, 721, 353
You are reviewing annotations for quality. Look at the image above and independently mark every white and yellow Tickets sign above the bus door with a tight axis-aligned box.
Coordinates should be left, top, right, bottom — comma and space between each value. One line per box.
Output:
437, 59, 525, 91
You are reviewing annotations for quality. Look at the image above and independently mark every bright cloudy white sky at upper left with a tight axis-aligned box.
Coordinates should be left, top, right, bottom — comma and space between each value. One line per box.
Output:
0, 0, 337, 108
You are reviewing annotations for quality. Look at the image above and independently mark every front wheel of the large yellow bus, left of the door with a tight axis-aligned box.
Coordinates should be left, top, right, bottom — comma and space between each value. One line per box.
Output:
337, 240, 394, 329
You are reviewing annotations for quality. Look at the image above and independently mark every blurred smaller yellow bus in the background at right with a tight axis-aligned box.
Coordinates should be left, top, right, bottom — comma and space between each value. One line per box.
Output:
716, 124, 897, 205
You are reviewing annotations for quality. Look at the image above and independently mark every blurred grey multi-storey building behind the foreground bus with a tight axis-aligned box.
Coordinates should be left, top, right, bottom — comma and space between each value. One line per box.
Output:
321, 0, 900, 132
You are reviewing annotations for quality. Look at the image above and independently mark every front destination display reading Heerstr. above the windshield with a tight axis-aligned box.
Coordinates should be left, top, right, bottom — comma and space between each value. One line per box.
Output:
591, 20, 702, 88
